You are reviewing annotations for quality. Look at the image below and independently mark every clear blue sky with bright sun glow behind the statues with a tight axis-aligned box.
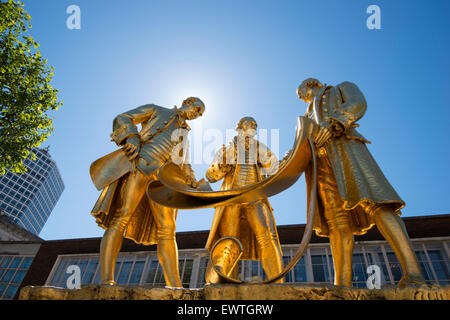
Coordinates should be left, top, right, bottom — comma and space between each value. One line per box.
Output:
18, 0, 450, 240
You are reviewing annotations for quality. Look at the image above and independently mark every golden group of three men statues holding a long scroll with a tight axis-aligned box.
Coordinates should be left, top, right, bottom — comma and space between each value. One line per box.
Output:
90, 78, 425, 288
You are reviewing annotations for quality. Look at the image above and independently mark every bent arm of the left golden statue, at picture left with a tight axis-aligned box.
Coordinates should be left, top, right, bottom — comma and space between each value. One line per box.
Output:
111, 104, 161, 146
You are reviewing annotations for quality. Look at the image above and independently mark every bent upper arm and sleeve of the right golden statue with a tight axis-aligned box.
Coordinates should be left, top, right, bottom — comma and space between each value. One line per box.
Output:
330, 81, 367, 130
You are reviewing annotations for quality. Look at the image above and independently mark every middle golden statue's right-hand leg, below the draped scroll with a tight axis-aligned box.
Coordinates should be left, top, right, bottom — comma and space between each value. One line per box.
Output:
246, 201, 284, 283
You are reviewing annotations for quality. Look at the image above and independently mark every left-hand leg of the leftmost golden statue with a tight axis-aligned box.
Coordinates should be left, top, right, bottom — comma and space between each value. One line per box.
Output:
100, 171, 148, 285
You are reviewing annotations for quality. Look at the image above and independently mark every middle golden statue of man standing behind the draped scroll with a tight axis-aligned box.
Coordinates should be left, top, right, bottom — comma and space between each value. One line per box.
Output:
206, 117, 283, 283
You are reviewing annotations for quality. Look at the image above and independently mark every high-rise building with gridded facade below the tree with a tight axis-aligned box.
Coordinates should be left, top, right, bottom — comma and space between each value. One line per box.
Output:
0, 148, 64, 235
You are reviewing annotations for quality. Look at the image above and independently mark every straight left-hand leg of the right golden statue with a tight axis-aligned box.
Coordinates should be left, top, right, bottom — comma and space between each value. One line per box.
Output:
317, 152, 354, 287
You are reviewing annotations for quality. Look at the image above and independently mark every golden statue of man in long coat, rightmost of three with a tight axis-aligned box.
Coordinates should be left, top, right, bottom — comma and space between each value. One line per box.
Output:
297, 78, 424, 286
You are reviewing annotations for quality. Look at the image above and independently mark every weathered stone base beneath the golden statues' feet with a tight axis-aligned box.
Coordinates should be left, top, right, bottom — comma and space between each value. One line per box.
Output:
19, 284, 450, 300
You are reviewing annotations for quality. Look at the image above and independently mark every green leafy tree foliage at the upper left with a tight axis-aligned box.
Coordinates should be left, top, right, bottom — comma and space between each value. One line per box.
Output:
0, 0, 62, 175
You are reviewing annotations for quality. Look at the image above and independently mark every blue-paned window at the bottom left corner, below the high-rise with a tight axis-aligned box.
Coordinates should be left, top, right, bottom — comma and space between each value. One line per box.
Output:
0, 255, 33, 299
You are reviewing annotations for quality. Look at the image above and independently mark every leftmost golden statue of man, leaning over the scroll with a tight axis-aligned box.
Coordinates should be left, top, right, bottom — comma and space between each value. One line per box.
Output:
91, 97, 205, 287
